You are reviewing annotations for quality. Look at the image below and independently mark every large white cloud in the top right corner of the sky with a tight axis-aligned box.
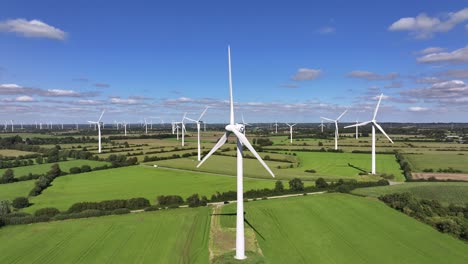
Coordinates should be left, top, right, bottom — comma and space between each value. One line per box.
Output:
388, 8, 468, 39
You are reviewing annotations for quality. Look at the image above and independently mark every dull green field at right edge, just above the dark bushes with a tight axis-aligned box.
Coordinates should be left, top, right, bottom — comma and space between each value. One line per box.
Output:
352, 182, 468, 205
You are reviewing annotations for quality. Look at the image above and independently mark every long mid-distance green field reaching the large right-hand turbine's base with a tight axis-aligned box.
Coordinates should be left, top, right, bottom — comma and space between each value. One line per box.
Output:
152, 152, 404, 181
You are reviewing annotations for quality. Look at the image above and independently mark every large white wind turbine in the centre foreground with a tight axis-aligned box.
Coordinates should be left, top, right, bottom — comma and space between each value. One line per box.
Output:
197, 46, 275, 259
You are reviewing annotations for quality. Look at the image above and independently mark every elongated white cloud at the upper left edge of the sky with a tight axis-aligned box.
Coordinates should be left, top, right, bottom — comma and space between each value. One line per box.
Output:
0, 18, 67, 40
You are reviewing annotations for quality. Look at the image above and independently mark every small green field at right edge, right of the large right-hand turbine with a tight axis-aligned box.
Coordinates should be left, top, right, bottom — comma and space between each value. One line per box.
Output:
405, 151, 468, 173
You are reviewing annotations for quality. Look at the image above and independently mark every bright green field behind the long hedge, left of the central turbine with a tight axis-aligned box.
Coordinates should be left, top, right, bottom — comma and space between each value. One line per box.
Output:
25, 166, 275, 212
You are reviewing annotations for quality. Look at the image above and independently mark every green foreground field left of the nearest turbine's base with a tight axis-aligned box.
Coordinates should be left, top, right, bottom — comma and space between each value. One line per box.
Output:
0, 207, 210, 263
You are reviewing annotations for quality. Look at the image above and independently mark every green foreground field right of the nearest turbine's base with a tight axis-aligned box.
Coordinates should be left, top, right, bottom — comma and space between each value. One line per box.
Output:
219, 194, 468, 264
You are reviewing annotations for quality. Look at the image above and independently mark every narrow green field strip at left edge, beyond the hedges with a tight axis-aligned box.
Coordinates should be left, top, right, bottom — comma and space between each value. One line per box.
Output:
0, 160, 110, 177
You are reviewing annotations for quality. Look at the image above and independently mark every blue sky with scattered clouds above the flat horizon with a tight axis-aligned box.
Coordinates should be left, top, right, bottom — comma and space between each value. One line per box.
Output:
0, 1, 468, 123
